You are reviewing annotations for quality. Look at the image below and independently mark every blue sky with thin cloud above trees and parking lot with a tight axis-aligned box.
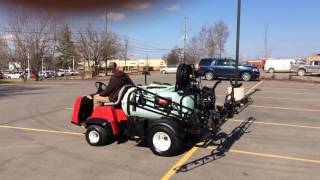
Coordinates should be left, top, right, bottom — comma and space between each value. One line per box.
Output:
2, 0, 320, 58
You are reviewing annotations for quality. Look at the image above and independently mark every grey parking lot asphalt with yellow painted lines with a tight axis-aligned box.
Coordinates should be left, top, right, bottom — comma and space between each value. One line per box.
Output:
0, 74, 320, 180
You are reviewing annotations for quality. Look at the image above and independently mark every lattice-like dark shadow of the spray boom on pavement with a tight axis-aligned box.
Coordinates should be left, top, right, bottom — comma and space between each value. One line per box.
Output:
176, 117, 255, 173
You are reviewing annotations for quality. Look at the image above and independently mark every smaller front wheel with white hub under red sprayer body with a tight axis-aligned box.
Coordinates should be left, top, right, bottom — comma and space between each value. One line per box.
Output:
86, 125, 113, 146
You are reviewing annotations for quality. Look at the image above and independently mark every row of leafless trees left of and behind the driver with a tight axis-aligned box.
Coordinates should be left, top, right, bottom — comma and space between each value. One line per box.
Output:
0, 11, 125, 75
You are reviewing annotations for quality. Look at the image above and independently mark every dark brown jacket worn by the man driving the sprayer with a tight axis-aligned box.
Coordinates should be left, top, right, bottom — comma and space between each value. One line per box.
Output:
99, 71, 134, 102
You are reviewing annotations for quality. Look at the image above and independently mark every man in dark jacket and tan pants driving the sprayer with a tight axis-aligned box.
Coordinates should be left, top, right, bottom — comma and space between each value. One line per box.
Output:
93, 62, 134, 107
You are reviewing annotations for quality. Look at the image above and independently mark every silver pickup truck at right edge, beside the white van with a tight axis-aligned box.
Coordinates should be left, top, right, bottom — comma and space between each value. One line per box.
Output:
290, 61, 320, 76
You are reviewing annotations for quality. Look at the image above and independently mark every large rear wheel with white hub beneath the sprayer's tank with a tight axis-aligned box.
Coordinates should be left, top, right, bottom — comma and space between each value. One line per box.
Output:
148, 125, 182, 156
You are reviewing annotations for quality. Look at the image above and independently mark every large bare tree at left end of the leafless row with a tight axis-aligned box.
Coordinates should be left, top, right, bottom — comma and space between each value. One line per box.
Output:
8, 11, 55, 80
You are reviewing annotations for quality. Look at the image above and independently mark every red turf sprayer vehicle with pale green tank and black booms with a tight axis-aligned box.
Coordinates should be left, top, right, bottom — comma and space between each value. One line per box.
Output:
72, 64, 250, 156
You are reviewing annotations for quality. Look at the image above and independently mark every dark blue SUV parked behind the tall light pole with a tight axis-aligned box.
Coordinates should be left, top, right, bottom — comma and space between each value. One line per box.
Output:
199, 58, 260, 81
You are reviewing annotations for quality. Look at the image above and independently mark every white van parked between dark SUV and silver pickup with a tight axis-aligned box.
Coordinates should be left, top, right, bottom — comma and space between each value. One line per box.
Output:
264, 59, 296, 73
